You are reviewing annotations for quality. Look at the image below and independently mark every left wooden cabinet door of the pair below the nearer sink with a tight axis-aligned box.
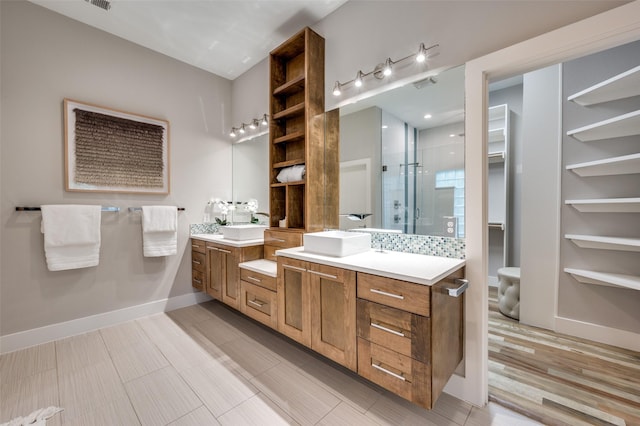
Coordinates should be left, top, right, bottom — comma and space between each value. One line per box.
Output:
278, 259, 311, 346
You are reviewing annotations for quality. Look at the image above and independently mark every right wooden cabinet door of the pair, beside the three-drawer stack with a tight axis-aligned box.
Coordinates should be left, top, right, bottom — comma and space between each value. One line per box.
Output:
307, 263, 357, 371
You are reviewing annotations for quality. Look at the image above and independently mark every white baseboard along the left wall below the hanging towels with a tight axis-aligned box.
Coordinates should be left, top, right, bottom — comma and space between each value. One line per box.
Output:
0, 292, 211, 354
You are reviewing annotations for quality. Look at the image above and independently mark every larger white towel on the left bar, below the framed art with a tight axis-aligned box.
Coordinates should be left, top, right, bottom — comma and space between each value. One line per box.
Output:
40, 204, 102, 271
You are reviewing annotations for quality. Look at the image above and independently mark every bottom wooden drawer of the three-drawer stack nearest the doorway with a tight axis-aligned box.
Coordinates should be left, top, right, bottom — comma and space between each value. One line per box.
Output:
358, 338, 432, 408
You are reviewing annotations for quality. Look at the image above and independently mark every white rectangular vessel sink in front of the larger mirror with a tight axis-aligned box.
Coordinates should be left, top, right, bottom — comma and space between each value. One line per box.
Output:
302, 231, 371, 257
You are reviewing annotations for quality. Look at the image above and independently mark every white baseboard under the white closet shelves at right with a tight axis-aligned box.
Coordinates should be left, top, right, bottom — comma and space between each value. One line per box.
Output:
555, 317, 640, 352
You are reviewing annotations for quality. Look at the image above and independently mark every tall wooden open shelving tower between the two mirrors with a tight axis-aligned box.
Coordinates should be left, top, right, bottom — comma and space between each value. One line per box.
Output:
269, 28, 339, 232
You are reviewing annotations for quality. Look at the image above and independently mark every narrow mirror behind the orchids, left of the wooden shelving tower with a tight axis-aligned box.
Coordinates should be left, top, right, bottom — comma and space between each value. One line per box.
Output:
232, 134, 269, 224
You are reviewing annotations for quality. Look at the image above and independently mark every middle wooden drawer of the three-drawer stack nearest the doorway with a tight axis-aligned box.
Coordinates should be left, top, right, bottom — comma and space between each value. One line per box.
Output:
357, 299, 431, 363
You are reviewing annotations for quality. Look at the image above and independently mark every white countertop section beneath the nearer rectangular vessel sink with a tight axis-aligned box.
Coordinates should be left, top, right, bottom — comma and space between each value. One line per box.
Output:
276, 247, 465, 285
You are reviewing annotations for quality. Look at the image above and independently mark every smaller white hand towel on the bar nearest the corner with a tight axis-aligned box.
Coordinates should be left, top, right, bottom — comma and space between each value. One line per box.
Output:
142, 206, 178, 257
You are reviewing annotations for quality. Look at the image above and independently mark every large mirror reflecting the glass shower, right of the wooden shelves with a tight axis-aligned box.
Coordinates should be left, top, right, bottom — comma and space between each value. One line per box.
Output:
340, 66, 464, 238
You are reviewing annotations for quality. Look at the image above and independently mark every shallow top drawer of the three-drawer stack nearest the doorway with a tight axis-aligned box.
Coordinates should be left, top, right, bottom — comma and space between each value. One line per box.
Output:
358, 272, 431, 317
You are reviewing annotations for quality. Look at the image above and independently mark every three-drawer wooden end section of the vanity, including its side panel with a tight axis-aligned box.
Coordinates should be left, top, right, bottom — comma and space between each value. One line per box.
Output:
357, 270, 464, 409
